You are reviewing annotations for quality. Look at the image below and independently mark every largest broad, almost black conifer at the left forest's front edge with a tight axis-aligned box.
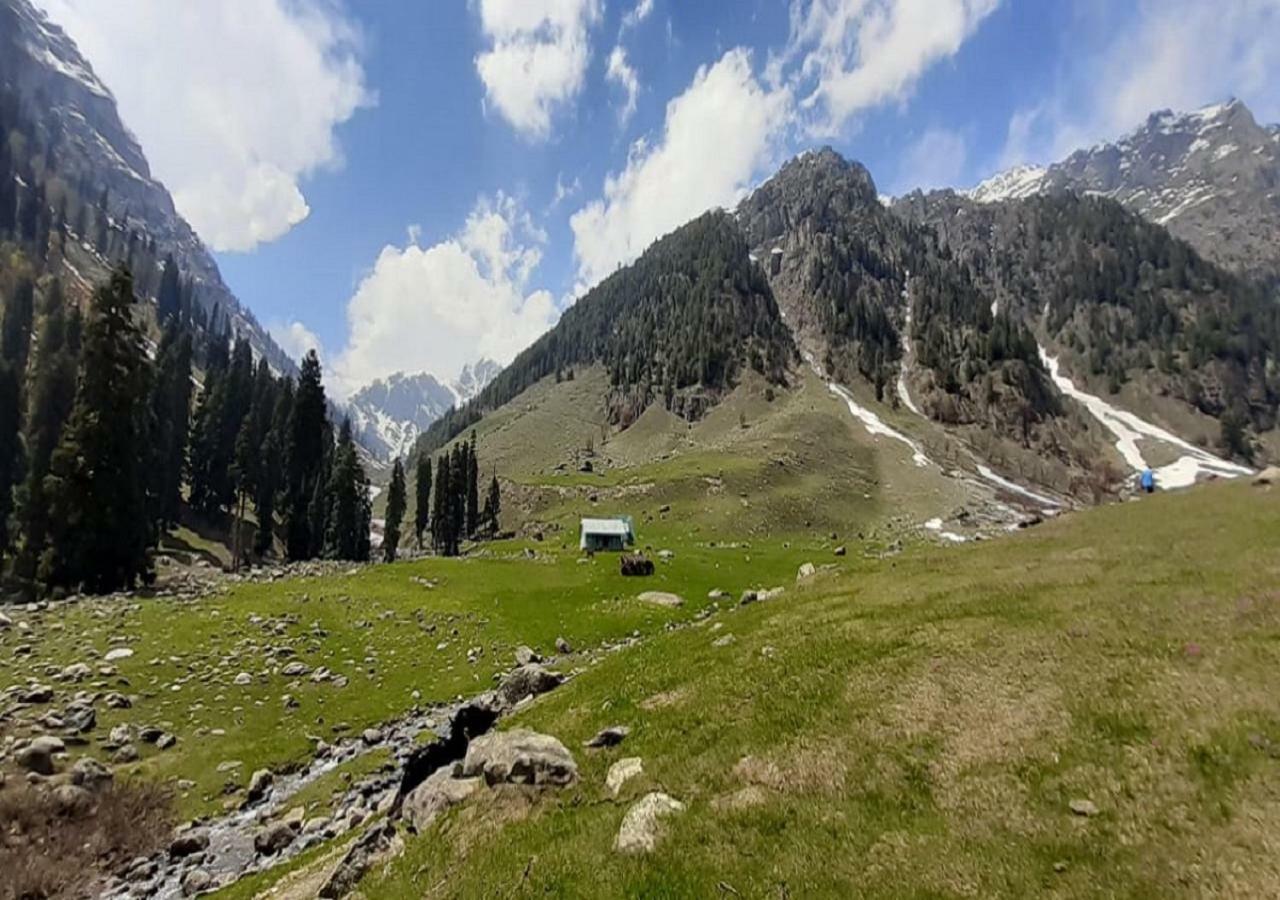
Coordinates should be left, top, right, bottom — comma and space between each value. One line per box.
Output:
40, 268, 154, 593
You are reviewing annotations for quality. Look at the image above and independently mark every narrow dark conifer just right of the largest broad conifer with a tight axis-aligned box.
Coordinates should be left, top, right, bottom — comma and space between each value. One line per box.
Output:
152, 319, 192, 529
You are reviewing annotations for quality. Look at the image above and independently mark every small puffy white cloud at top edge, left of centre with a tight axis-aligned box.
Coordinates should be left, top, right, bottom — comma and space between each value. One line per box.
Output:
475, 0, 600, 140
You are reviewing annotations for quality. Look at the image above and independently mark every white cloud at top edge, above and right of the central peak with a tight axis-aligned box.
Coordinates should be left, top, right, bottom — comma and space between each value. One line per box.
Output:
769, 0, 1000, 134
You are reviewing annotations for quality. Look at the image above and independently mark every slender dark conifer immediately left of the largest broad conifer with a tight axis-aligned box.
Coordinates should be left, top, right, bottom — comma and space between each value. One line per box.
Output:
14, 280, 82, 584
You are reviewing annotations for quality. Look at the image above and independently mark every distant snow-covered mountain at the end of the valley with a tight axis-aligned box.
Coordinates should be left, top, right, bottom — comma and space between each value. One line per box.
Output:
346, 358, 502, 461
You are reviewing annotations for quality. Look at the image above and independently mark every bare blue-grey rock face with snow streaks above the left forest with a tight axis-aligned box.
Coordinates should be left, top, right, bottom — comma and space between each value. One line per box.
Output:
0, 0, 294, 371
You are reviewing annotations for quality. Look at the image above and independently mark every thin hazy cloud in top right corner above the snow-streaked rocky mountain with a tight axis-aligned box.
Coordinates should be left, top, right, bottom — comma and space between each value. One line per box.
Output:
1000, 0, 1280, 166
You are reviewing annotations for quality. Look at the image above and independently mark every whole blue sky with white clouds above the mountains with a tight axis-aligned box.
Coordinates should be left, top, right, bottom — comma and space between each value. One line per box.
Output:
36, 0, 1280, 397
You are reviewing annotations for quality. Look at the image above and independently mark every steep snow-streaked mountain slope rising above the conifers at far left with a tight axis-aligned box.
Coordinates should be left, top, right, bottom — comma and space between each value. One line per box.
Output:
0, 0, 296, 373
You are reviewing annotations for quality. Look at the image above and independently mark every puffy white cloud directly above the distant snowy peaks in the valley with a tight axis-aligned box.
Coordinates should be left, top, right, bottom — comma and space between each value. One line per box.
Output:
332, 193, 557, 397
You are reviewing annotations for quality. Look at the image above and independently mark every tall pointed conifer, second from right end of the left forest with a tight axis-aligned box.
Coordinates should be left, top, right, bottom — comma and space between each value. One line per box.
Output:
285, 351, 328, 559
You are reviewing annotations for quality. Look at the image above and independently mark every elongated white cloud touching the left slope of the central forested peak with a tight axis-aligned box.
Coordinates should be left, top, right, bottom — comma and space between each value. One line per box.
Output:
570, 49, 790, 292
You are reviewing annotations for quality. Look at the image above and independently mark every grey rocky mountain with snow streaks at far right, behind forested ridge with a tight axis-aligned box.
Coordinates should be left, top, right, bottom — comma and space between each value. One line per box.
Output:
966, 100, 1280, 279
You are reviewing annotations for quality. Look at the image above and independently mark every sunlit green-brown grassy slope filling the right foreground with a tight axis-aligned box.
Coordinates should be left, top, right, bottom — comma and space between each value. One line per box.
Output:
361, 484, 1280, 899
